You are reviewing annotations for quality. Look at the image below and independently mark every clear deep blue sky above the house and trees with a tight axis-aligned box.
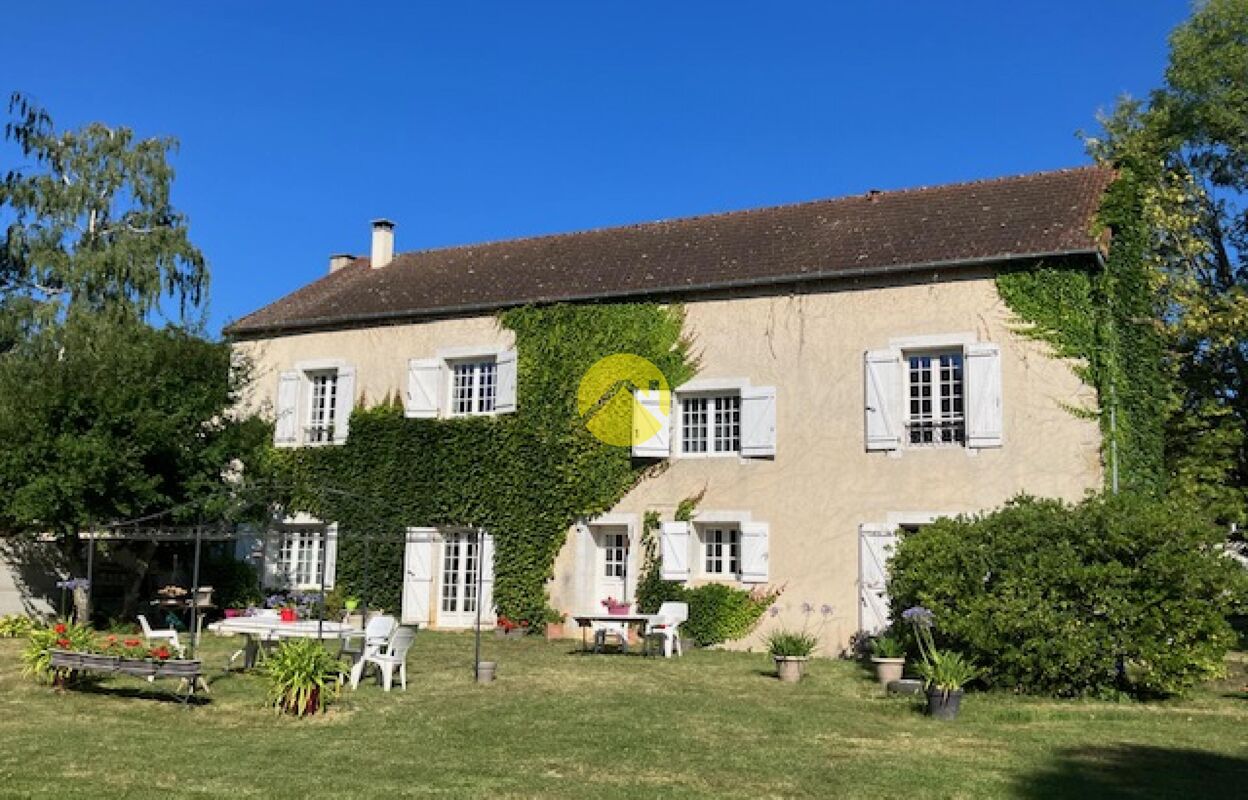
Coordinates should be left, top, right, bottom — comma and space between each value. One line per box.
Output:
0, 0, 1188, 333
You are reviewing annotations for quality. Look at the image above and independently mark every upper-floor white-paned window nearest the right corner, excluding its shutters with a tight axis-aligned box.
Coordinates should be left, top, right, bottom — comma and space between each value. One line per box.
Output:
906, 352, 966, 446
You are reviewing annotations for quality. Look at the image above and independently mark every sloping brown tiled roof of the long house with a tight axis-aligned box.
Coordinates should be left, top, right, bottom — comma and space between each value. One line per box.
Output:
226, 167, 1113, 337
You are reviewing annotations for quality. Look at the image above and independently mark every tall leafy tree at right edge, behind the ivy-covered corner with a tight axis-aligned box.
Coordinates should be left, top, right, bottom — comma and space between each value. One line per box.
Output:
1090, 0, 1248, 522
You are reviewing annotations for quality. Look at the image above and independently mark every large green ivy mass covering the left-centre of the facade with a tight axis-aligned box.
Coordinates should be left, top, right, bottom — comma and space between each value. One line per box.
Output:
274, 303, 696, 624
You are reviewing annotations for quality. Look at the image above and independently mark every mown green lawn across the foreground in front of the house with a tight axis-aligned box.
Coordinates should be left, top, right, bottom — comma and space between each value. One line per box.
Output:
0, 633, 1248, 799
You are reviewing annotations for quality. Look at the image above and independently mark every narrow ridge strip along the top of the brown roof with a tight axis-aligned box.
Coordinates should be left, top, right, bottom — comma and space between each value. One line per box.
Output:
384, 163, 1109, 266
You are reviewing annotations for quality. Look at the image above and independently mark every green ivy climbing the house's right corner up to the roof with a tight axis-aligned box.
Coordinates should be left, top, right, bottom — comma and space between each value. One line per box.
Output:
996, 172, 1173, 492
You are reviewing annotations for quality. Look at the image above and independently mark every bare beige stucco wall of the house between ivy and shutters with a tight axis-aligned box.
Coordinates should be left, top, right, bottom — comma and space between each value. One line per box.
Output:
232, 268, 1101, 653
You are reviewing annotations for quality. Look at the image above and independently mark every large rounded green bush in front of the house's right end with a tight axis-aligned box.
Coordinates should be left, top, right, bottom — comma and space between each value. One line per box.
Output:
889, 495, 1244, 696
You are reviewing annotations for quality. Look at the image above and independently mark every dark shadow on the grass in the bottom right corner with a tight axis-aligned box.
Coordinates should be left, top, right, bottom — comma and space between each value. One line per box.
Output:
1015, 745, 1248, 800
